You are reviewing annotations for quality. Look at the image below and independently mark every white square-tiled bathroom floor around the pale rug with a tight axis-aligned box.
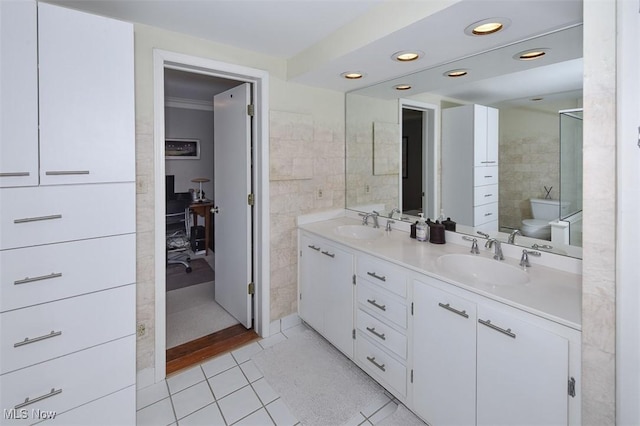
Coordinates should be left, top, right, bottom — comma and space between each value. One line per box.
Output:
137, 325, 412, 426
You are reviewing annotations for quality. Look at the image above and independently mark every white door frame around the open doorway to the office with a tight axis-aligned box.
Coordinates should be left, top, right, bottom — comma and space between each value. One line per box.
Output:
153, 49, 270, 382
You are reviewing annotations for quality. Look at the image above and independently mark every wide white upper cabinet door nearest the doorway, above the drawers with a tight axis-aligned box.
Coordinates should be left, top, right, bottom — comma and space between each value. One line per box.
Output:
38, 3, 135, 185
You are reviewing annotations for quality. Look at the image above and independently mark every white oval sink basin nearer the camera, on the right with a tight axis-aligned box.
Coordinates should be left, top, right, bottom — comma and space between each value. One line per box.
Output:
436, 254, 529, 286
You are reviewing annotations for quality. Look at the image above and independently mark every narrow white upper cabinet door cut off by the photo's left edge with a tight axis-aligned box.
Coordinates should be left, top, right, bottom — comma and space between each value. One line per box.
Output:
0, 1, 38, 188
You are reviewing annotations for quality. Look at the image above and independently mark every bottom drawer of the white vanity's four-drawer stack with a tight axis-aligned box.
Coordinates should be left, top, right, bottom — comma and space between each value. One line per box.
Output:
356, 332, 407, 396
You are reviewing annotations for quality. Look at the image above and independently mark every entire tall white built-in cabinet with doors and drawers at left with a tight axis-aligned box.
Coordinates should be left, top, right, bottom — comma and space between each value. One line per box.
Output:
0, 0, 136, 425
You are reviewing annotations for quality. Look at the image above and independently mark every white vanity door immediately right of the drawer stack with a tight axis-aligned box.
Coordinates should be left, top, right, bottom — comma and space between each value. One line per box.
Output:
413, 281, 476, 426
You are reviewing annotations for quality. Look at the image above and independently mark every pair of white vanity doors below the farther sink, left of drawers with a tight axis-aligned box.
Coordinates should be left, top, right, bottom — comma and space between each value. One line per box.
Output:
298, 232, 354, 358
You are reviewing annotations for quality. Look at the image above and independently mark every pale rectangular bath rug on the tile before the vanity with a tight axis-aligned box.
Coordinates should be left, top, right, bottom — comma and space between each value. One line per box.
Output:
252, 330, 384, 426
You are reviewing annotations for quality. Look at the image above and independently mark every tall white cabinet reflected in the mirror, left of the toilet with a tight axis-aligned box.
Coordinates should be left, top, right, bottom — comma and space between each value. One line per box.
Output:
442, 105, 499, 231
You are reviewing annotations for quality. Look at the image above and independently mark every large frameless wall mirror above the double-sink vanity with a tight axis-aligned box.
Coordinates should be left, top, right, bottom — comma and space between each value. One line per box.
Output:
346, 24, 583, 258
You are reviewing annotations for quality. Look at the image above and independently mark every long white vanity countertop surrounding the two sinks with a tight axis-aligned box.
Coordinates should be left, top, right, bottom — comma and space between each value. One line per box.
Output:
298, 217, 582, 331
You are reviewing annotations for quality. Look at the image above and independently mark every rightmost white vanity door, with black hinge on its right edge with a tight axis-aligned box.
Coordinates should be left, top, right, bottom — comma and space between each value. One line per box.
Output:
477, 307, 569, 426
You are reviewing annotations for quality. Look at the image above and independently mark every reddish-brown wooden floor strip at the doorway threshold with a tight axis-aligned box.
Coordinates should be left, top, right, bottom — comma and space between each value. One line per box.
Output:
167, 324, 260, 375
